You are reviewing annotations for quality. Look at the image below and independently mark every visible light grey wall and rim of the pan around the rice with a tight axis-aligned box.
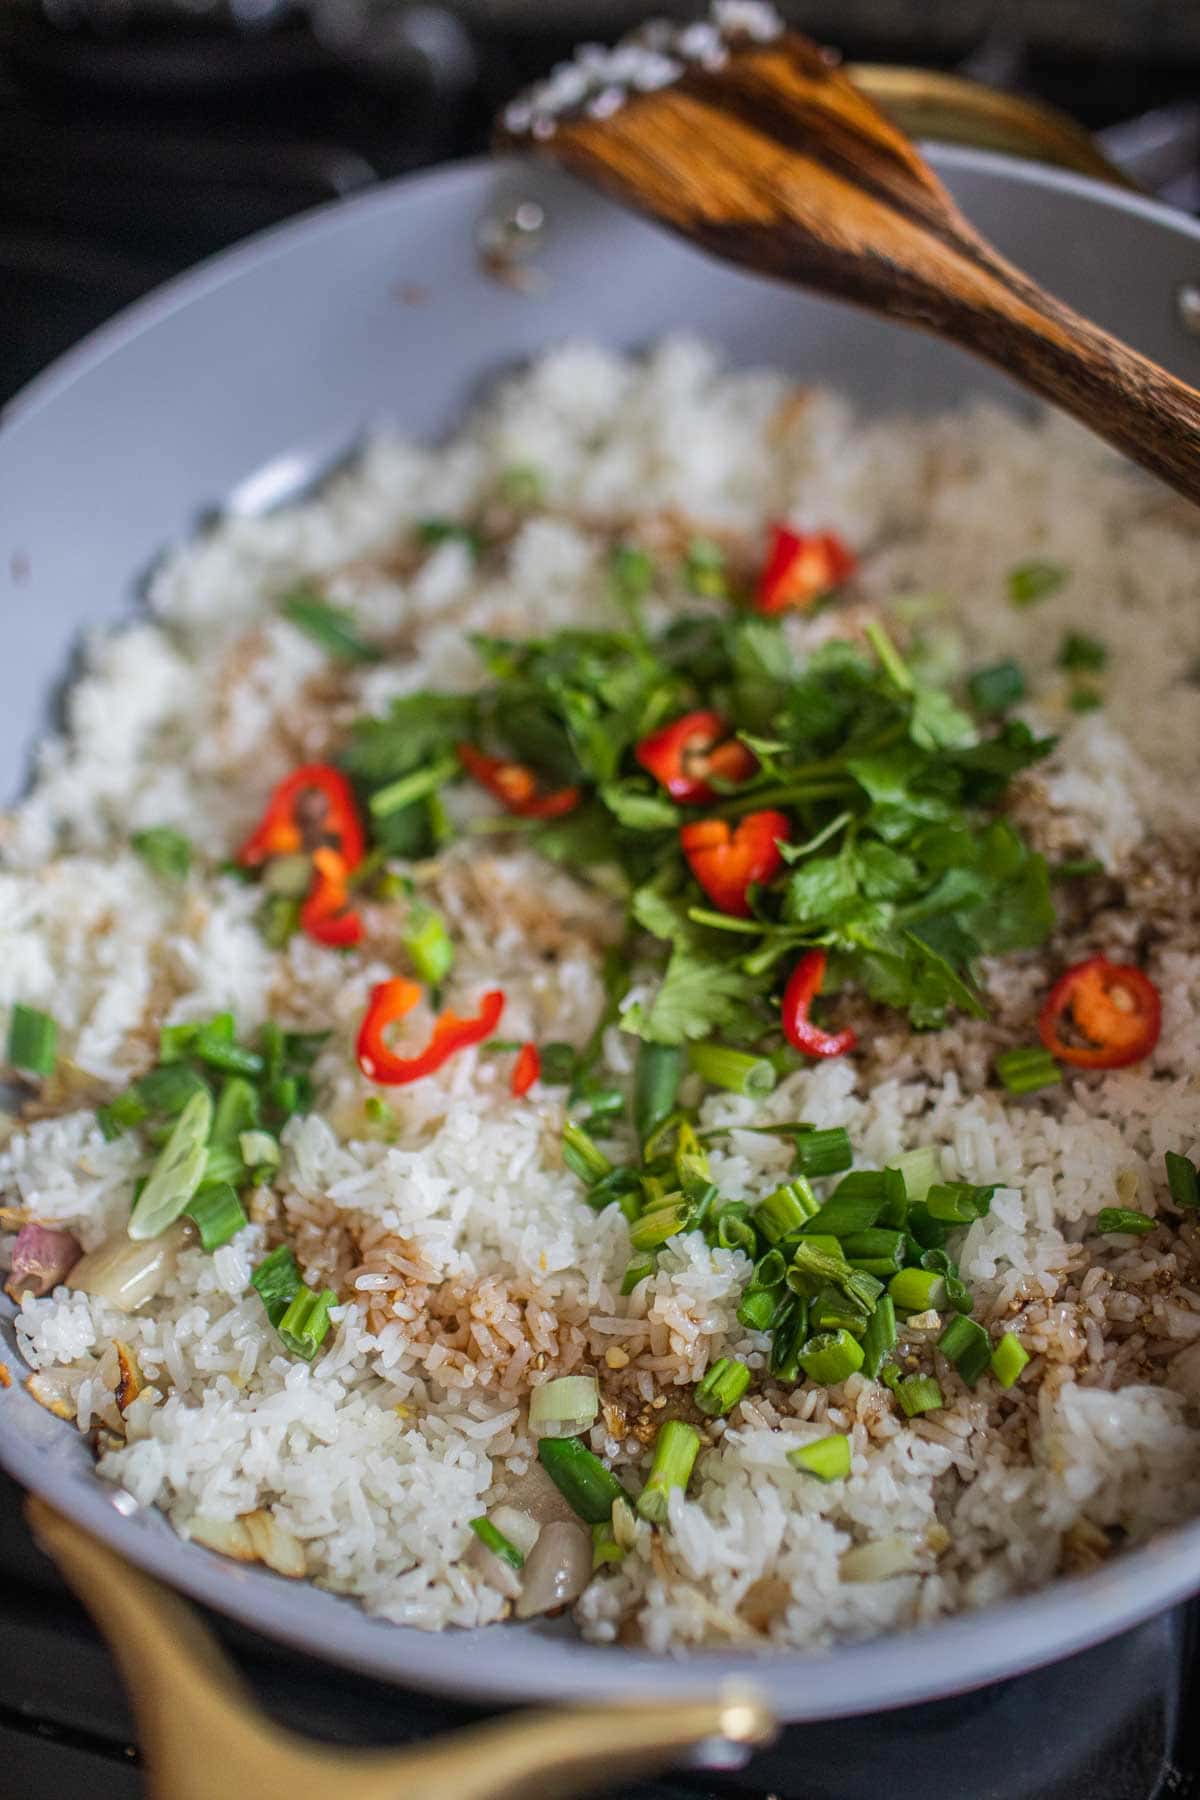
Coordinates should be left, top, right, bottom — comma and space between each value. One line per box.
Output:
0, 133, 1200, 1721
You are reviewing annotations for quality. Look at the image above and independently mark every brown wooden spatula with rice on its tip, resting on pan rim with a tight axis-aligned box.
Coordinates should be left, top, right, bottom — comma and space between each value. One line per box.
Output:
498, 5, 1200, 502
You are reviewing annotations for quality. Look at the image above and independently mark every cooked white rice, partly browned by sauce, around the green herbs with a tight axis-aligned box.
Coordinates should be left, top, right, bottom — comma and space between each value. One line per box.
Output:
0, 340, 1200, 1649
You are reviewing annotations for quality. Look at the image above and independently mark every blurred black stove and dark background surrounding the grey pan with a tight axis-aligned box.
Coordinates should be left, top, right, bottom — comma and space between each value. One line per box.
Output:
0, 0, 1200, 1800
